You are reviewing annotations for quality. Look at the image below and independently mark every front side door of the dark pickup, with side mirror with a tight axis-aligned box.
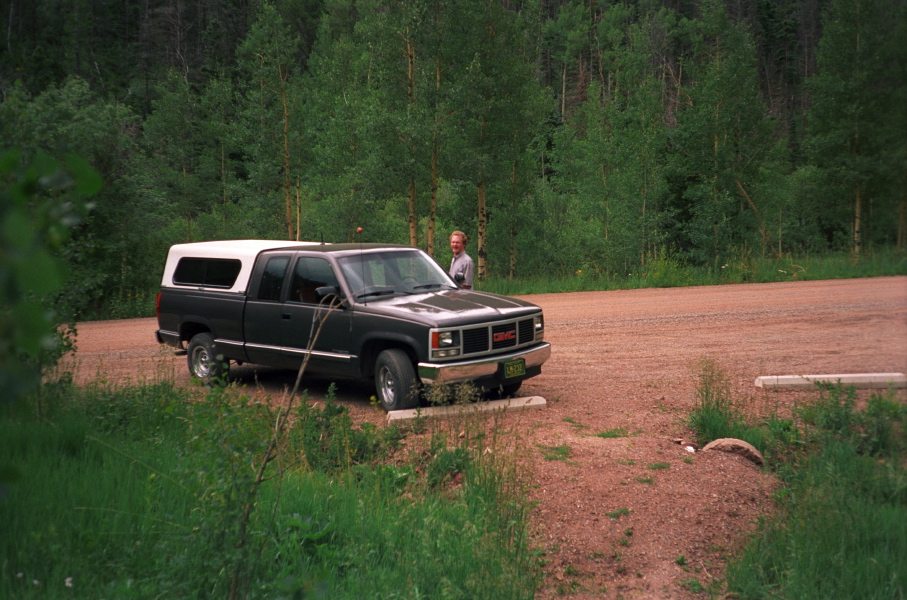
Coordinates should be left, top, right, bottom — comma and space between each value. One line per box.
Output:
281, 255, 354, 376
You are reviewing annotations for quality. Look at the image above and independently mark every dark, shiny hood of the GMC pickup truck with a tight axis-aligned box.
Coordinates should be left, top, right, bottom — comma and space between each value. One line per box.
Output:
359, 290, 541, 327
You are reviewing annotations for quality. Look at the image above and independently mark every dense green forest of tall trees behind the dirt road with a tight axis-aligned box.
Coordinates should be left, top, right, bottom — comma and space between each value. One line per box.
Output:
0, 0, 907, 314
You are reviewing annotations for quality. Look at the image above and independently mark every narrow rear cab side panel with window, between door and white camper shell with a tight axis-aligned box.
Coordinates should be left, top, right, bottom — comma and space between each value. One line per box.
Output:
243, 253, 293, 368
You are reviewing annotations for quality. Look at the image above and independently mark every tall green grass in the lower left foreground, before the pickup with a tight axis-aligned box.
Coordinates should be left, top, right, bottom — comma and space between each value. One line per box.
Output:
0, 384, 538, 598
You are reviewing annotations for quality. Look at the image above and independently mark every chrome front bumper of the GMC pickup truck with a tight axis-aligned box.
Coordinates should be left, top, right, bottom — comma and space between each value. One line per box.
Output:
418, 342, 551, 385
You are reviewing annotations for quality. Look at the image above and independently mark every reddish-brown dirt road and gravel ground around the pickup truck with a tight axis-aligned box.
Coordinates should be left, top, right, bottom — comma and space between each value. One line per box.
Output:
69, 277, 907, 600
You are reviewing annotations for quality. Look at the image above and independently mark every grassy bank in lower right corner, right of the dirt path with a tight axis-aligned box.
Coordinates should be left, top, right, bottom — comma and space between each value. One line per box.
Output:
690, 362, 907, 600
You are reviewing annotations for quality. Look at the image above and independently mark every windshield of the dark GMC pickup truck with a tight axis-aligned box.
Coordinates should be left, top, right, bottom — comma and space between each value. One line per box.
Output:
338, 250, 456, 300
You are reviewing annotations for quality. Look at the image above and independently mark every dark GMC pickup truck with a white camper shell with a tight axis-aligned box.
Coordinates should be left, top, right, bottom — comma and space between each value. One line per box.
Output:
155, 240, 551, 411
